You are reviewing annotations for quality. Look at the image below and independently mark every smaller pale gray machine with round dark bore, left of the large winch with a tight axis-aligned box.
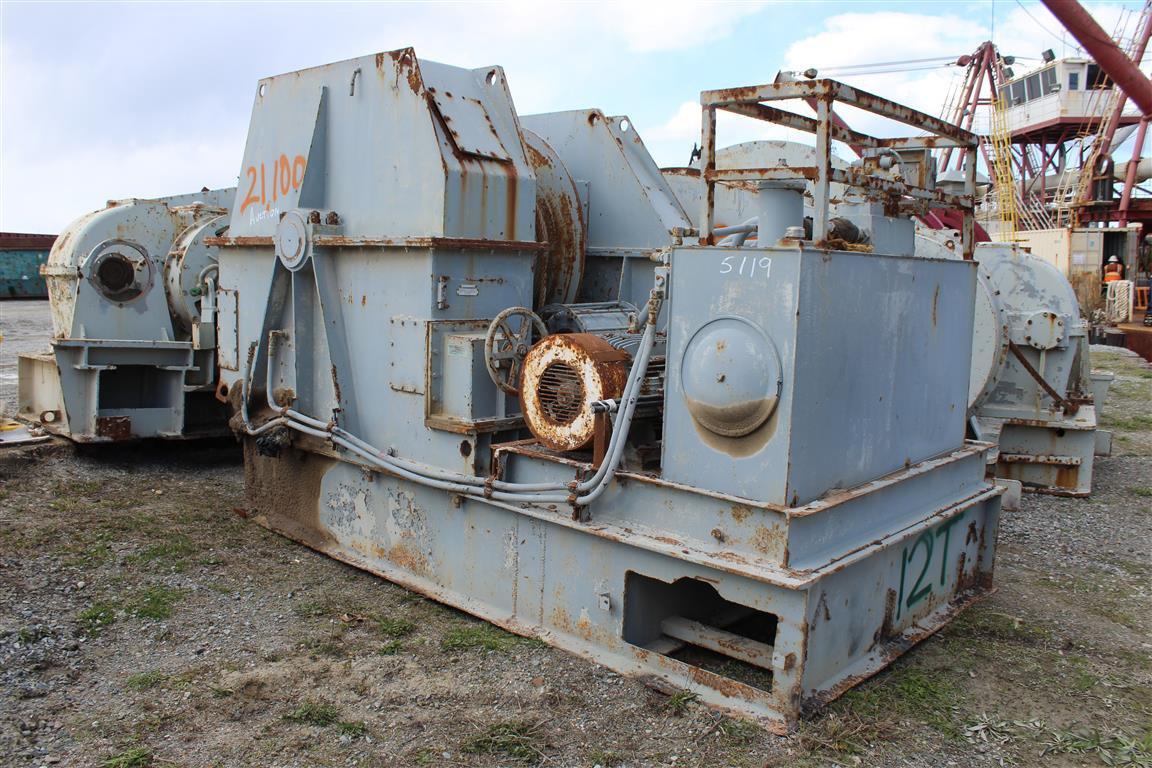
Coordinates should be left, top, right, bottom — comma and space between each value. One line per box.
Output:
18, 189, 235, 442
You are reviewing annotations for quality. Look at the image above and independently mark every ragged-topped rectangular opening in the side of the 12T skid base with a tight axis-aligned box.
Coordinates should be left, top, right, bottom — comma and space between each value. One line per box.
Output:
623, 571, 779, 692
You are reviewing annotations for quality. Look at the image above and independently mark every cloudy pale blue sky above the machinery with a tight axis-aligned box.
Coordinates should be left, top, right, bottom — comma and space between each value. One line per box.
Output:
0, 0, 1140, 233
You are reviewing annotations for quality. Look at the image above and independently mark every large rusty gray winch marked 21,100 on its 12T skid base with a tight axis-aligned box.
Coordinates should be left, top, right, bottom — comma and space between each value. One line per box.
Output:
214, 48, 1001, 732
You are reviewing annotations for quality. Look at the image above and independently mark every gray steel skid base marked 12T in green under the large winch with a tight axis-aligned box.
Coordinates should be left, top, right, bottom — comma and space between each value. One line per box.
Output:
245, 439, 1001, 733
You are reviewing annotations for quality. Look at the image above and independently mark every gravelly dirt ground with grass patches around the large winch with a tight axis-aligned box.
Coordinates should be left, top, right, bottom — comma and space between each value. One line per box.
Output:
0, 297, 1152, 768
